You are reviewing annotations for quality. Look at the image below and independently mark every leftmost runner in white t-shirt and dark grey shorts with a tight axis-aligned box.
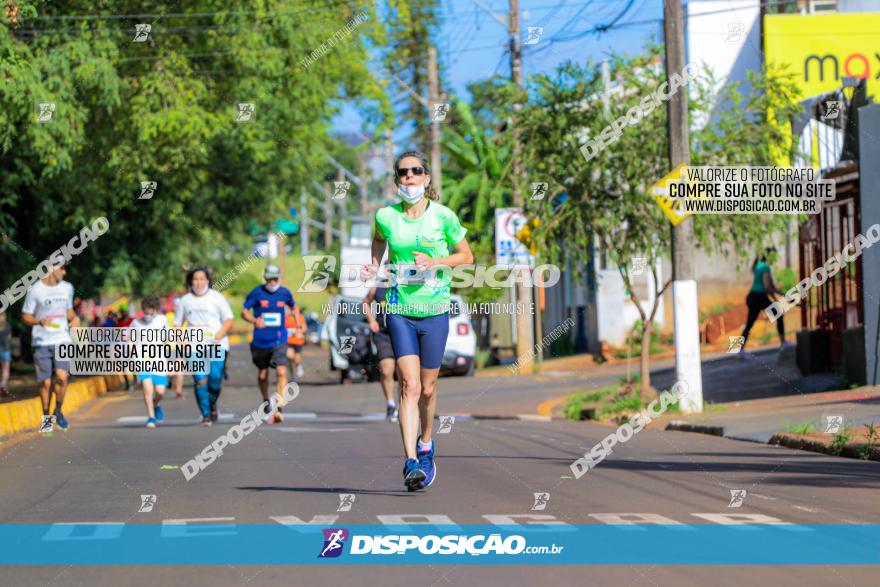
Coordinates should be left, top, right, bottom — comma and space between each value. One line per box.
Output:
21, 264, 79, 432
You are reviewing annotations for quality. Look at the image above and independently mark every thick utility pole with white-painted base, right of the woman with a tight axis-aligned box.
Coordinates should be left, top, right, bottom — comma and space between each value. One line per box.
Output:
663, 0, 703, 413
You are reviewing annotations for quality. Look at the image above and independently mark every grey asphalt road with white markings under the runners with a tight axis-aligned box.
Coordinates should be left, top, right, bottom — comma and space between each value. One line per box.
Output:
0, 347, 880, 587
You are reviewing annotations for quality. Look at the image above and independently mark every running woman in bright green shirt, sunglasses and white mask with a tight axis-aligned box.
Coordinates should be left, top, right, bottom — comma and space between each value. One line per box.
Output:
361, 151, 474, 491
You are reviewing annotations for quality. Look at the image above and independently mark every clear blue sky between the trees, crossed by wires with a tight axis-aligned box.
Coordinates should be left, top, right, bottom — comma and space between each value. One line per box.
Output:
334, 0, 663, 132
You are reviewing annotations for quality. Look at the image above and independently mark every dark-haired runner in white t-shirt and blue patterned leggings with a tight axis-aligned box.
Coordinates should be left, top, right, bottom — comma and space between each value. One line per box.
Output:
174, 266, 233, 426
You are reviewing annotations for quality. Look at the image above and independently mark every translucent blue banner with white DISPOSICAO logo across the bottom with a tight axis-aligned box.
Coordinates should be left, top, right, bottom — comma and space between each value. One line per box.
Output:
0, 523, 880, 565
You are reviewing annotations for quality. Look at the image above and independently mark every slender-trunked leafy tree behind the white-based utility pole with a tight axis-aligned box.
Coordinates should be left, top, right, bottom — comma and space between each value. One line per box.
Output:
521, 46, 798, 398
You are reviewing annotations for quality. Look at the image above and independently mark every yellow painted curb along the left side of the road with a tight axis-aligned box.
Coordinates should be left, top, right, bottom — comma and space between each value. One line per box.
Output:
0, 375, 125, 436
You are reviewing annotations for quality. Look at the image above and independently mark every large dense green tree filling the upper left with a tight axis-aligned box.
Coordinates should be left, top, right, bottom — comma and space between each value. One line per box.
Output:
0, 0, 388, 295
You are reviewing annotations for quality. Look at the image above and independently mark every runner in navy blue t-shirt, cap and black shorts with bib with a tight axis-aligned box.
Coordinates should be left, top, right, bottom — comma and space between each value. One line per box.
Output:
241, 265, 295, 423
